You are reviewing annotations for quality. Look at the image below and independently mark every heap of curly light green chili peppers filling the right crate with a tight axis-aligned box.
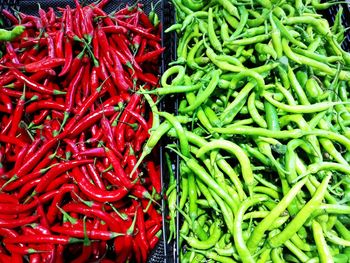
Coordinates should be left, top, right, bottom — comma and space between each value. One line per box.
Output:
137, 0, 350, 262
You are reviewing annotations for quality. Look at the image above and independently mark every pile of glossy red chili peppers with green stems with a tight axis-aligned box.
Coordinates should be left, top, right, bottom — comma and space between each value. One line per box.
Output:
0, 0, 163, 262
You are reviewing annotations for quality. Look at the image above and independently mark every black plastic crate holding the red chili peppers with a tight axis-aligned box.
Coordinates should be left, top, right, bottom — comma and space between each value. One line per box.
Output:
0, 0, 174, 263
